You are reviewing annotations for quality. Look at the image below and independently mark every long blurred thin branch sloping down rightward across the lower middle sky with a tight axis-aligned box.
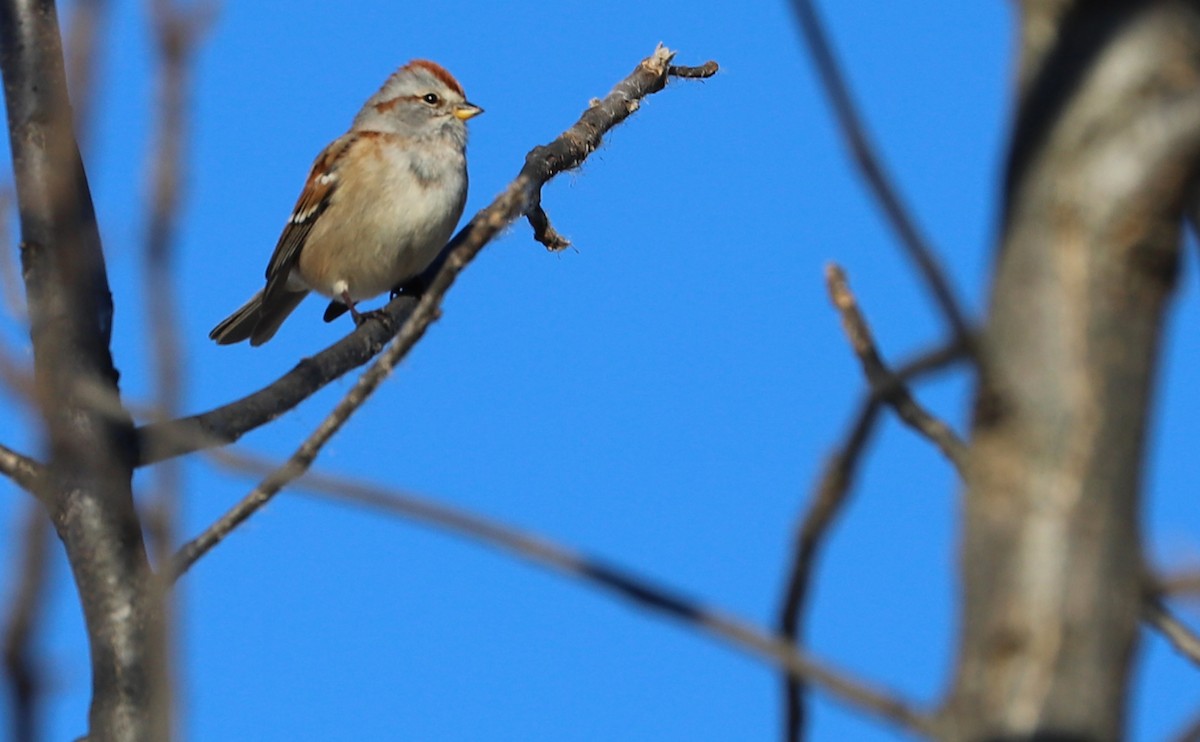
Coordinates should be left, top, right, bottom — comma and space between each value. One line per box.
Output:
199, 441, 934, 735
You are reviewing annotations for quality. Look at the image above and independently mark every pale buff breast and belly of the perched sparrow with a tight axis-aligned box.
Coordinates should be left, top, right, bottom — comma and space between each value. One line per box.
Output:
298, 132, 467, 301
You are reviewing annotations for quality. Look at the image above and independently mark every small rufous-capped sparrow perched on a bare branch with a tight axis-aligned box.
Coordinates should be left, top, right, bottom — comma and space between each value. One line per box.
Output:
209, 59, 484, 346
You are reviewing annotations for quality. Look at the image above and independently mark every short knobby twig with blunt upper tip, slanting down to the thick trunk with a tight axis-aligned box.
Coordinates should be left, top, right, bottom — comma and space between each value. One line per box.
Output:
826, 263, 967, 468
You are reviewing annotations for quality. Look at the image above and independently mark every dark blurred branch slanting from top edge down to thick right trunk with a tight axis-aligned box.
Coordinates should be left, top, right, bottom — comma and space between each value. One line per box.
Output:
792, 0, 972, 348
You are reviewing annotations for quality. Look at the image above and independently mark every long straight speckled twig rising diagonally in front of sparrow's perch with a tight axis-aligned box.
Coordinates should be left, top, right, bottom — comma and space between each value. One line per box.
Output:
172, 44, 710, 576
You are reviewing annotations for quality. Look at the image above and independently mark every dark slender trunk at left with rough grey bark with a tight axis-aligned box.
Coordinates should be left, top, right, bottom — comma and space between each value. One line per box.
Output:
0, 0, 167, 740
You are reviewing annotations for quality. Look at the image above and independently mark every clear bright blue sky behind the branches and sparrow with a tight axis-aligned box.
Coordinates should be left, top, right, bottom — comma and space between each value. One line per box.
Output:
0, 0, 1200, 741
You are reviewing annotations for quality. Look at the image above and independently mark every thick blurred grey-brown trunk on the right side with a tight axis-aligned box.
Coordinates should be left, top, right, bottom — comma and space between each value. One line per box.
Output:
943, 1, 1200, 740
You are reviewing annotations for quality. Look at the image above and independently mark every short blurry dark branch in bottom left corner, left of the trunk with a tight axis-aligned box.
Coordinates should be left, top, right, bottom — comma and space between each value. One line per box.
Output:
4, 501, 50, 742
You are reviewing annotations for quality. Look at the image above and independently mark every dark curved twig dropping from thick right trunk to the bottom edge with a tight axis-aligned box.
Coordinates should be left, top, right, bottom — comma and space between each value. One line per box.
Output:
778, 343, 966, 742
